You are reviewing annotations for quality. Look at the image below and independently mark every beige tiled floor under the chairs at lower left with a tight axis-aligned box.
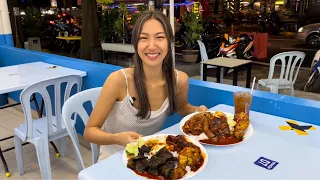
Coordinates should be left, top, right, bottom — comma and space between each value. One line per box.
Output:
0, 108, 91, 180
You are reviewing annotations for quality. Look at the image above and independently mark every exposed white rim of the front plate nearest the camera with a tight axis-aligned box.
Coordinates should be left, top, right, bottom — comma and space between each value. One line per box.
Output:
122, 134, 208, 179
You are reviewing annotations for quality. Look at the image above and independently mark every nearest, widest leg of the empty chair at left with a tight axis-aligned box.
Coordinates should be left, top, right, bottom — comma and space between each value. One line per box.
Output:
34, 137, 52, 180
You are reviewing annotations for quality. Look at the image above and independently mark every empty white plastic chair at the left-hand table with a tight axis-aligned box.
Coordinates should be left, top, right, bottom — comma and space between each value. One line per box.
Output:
14, 75, 82, 179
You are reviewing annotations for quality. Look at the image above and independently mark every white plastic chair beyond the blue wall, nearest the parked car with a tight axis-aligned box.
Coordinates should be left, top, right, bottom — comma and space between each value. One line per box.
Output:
257, 51, 305, 96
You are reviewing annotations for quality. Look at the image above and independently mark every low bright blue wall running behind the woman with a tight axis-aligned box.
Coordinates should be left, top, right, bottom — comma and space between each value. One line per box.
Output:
0, 46, 320, 134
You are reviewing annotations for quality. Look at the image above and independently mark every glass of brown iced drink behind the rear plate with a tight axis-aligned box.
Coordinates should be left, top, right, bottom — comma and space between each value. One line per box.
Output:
233, 92, 252, 116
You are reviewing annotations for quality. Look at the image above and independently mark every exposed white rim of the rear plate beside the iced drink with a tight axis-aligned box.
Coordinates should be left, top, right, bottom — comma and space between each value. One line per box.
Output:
179, 111, 254, 146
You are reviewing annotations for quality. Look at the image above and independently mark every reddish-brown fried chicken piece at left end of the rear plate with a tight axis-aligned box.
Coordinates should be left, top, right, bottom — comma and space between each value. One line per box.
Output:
182, 113, 203, 136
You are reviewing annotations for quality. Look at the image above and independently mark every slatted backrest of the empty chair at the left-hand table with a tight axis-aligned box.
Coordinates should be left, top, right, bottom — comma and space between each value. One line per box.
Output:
20, 75, 82, 140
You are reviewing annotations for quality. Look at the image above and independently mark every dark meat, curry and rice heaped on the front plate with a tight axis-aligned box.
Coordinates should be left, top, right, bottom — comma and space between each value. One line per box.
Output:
126, 135, 206, 179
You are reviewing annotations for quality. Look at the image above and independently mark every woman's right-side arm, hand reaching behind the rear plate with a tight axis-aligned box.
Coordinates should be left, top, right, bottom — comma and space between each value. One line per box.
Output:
177, 71, 208, 116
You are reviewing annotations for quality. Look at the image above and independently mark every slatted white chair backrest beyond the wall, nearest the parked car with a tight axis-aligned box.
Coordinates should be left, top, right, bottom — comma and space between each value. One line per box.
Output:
267, 51, 306, 85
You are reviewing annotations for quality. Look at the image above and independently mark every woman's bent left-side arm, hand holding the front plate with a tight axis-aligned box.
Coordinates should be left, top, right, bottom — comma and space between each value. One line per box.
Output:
84, 71, 139, 145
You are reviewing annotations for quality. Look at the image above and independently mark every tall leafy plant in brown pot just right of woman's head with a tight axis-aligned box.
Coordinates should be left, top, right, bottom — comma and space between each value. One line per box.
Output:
182, 12, 203, 62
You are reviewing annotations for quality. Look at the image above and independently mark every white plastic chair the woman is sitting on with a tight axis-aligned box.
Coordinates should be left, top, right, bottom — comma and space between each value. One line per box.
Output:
62, 87, 102, 170
